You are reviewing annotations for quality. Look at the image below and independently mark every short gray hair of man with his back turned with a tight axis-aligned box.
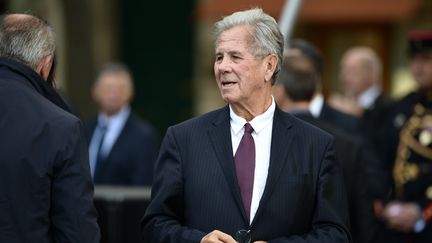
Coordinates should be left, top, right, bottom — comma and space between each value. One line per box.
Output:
0, 14, 55, 69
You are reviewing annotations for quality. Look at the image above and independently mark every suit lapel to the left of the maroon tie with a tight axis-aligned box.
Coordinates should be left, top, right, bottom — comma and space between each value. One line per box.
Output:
208, 106, 249, 224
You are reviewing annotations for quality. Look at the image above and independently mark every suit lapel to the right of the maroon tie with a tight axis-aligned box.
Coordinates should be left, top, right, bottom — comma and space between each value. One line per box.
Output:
252, 107, 294, 225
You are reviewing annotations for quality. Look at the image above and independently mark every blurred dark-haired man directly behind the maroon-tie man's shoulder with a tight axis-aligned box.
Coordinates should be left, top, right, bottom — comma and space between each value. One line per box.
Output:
274, 57, 376, 243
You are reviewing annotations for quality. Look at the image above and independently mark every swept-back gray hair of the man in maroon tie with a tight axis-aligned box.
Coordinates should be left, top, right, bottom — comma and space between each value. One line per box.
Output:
214, 8, 284, 84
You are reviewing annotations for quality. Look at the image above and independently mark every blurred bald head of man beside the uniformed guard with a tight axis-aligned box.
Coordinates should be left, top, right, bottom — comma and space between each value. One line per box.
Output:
340, 46, 381, 97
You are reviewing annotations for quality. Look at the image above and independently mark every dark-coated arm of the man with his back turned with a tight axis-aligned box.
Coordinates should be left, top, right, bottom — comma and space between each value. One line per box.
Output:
47, 121, 100, 243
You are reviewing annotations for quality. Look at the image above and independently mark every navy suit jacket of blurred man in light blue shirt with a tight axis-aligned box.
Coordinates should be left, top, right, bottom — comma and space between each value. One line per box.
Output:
86, 113, 160, 186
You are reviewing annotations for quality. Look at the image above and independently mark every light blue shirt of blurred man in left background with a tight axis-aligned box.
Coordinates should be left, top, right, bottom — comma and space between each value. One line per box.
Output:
89, 106, 130, 176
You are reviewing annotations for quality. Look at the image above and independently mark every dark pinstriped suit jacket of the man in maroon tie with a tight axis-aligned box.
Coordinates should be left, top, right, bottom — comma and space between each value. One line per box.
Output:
141, 106, 350, 243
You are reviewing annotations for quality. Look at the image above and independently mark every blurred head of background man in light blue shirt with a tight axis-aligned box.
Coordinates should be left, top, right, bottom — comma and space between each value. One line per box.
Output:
93, 72, 132, 115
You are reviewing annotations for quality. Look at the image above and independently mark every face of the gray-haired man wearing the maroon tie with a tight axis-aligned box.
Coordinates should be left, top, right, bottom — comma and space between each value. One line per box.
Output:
214, 26, 271, 105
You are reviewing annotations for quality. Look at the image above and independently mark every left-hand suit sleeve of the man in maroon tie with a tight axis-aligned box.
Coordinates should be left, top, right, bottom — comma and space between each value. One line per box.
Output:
141, 128, 205, 242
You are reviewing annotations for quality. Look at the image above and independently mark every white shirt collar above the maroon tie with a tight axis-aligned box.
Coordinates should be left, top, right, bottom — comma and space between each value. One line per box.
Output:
229, 96, 276, 134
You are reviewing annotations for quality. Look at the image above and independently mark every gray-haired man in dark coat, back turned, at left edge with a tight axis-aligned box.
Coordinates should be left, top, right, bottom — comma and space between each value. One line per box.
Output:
0, 14, 100, 243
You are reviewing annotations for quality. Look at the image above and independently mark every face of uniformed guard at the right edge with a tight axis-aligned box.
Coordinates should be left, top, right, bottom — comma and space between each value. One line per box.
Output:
411, 53, 432, 91
